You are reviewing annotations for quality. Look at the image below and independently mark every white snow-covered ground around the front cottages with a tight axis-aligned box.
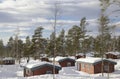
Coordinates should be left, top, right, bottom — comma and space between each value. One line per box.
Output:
0, 60, 120, 79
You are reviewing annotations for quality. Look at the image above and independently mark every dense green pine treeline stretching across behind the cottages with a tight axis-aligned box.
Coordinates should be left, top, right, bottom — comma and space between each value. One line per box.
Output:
0, 18, 120, 58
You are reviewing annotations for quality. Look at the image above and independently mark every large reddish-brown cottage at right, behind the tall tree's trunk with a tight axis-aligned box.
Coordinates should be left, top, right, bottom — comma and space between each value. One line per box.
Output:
76, 57, 117, 74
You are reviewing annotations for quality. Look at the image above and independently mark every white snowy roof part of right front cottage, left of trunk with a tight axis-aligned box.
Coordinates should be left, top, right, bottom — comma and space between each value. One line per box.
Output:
76, 57, 102, 64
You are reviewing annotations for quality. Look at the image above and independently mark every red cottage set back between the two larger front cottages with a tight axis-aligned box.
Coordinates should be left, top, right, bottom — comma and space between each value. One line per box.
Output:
50, 57, 75, 67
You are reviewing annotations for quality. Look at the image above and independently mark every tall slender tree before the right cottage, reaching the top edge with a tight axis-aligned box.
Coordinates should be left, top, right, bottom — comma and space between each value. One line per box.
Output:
98, 0, 111, 76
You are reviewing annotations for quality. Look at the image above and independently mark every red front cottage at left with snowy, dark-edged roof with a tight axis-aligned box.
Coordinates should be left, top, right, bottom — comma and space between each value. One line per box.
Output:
24, 62, 61, 77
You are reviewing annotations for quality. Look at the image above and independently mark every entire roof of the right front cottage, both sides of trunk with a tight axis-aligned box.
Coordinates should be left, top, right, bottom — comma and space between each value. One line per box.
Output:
76, 57, 117, 64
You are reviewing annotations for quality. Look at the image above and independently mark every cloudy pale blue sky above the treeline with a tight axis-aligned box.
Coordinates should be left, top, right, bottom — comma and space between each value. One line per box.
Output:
0, 0, 120, 44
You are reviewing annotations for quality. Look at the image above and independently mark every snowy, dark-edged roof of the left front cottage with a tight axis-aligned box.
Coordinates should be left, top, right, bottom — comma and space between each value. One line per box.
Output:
25, 62, 61, 71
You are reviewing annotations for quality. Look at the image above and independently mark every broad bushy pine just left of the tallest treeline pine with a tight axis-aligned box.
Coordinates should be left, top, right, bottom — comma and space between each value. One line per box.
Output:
66, 25, 82, 55
